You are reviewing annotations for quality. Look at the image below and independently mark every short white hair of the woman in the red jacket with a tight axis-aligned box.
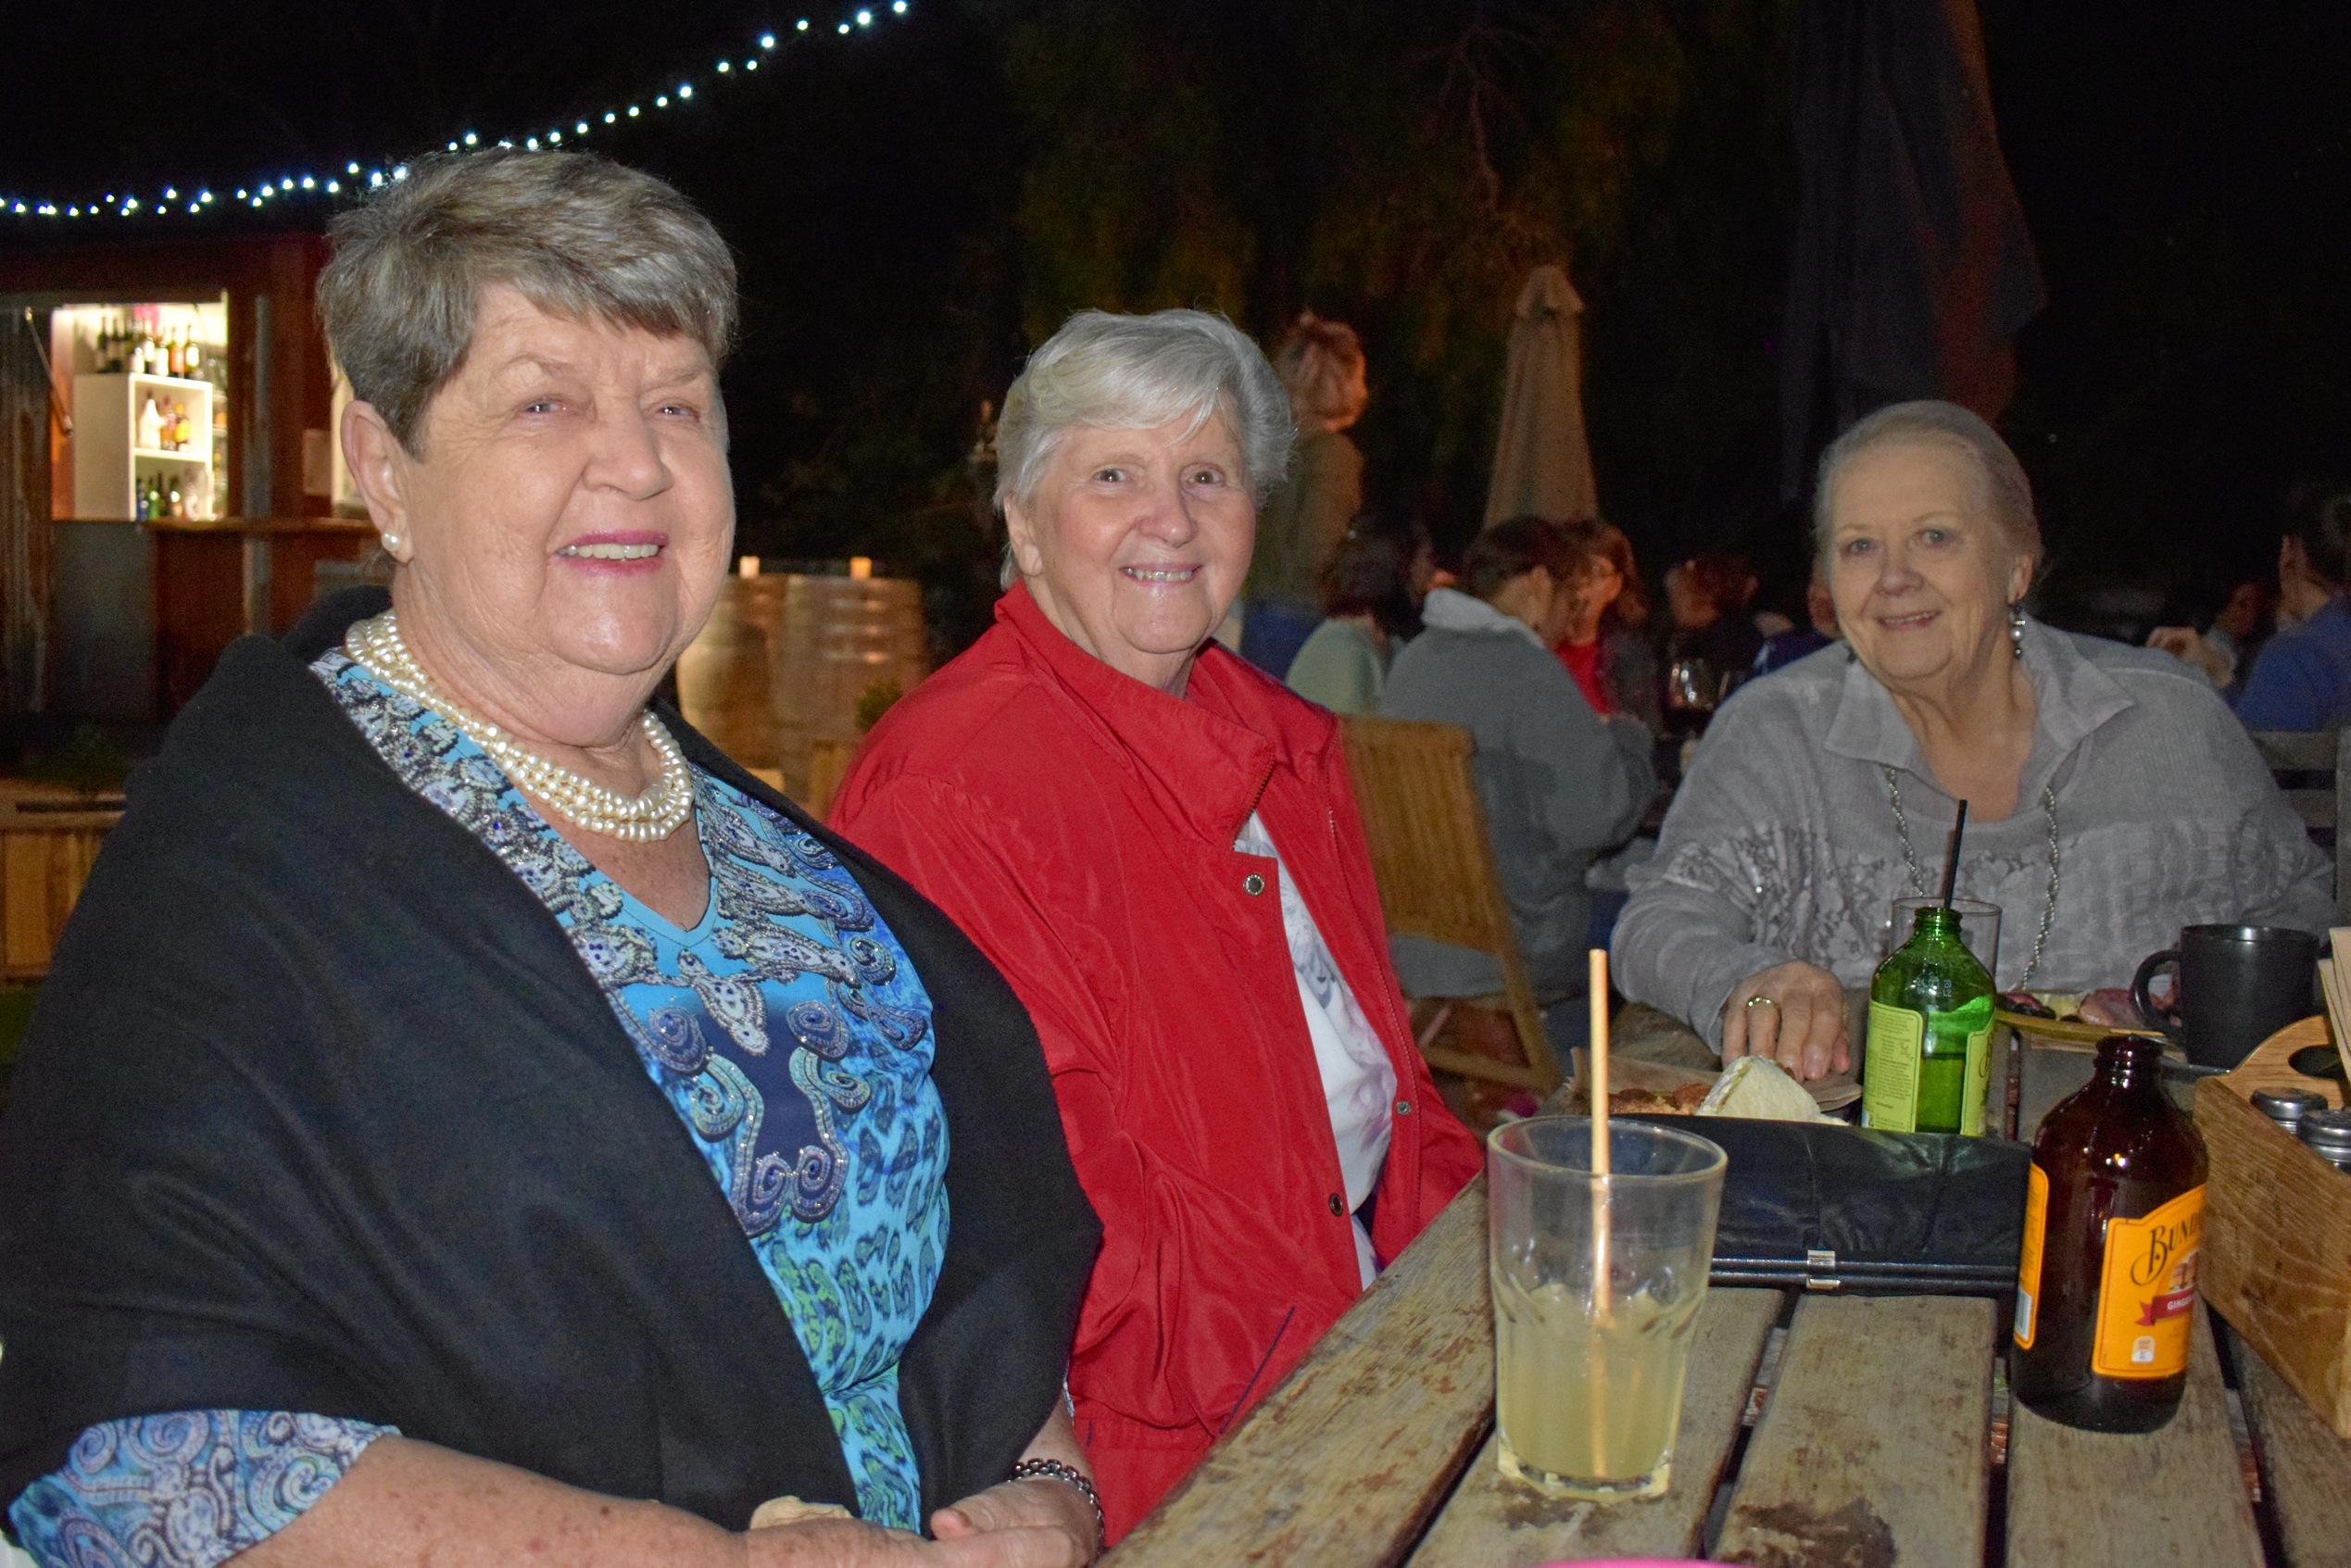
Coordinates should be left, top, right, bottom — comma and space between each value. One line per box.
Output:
997, 310, 1298, 508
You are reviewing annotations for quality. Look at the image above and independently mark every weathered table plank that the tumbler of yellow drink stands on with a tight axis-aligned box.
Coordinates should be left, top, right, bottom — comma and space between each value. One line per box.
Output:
1413, 1290, 1782, 1568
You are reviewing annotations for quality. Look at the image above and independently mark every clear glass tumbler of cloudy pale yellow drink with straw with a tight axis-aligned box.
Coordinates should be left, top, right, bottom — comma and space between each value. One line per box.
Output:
1486, 1117, 1728, 1502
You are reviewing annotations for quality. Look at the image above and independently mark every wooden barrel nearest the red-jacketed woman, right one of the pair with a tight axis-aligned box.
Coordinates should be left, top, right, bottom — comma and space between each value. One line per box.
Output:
771, 576, 931, 799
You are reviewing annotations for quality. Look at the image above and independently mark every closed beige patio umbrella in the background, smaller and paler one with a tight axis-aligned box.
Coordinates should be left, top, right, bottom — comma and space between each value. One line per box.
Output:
1486, 263, 1599, 529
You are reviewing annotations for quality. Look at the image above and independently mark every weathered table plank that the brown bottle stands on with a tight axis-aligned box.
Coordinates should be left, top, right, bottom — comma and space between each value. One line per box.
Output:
2007, 1311, 2257, 1568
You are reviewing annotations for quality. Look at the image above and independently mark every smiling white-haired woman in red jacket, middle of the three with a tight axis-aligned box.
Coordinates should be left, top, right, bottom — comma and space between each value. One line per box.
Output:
835, 310, 1478, 1540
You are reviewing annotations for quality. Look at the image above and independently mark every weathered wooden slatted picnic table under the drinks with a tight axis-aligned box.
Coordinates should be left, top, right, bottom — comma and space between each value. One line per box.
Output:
1107, 1114, 2351, 1568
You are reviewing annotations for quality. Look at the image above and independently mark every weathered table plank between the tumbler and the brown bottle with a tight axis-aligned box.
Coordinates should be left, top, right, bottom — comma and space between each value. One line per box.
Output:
1712, 1298, 1993, 1568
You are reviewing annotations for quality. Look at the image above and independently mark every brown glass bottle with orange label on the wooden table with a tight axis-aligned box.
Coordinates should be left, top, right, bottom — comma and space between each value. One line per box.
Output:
2007, 1035, 2206, 1432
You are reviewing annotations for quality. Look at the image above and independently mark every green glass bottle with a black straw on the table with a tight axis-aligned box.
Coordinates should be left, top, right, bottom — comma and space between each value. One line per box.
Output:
1862, 905, 1992, 1138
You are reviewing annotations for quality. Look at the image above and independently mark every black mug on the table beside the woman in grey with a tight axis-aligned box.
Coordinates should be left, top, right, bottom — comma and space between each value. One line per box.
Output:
2130, 926, 2318, 1067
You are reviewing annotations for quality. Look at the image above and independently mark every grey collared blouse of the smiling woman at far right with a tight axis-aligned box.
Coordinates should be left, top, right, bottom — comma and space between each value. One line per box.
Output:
1613, 623, 2334, 1044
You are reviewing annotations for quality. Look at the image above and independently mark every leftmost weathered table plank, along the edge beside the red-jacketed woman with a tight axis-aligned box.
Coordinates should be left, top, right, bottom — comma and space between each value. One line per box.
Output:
1105, 1178, 1493, 1568
